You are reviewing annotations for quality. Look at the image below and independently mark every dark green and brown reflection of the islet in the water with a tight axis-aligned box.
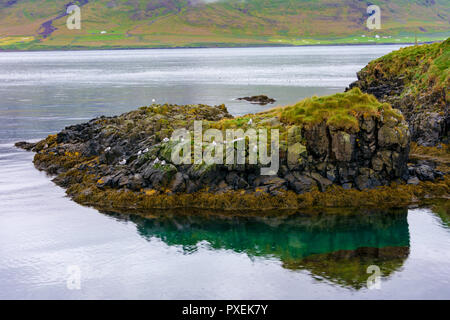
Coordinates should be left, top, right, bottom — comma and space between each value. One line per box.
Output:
103, 209, 409, 289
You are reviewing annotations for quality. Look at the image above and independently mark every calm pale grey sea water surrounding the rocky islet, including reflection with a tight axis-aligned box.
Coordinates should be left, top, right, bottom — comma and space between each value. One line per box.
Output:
0, 46, 450, 299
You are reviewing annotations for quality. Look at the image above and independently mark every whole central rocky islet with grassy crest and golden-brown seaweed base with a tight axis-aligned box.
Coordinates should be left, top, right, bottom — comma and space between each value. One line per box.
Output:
16, 88, 450, 212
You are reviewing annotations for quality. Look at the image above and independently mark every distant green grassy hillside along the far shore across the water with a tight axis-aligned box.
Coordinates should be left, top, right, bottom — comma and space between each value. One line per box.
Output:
0, 0, 450, 49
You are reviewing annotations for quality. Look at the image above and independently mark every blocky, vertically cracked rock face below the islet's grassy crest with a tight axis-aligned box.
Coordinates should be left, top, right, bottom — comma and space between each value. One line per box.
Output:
282, 91, 409, 191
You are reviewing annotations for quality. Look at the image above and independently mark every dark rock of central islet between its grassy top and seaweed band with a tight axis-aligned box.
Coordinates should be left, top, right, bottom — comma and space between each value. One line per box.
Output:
18, 92, 439, 210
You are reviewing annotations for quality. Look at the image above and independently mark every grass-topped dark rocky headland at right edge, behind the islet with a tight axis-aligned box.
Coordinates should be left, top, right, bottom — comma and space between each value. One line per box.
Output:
350, 39, 450, 146
